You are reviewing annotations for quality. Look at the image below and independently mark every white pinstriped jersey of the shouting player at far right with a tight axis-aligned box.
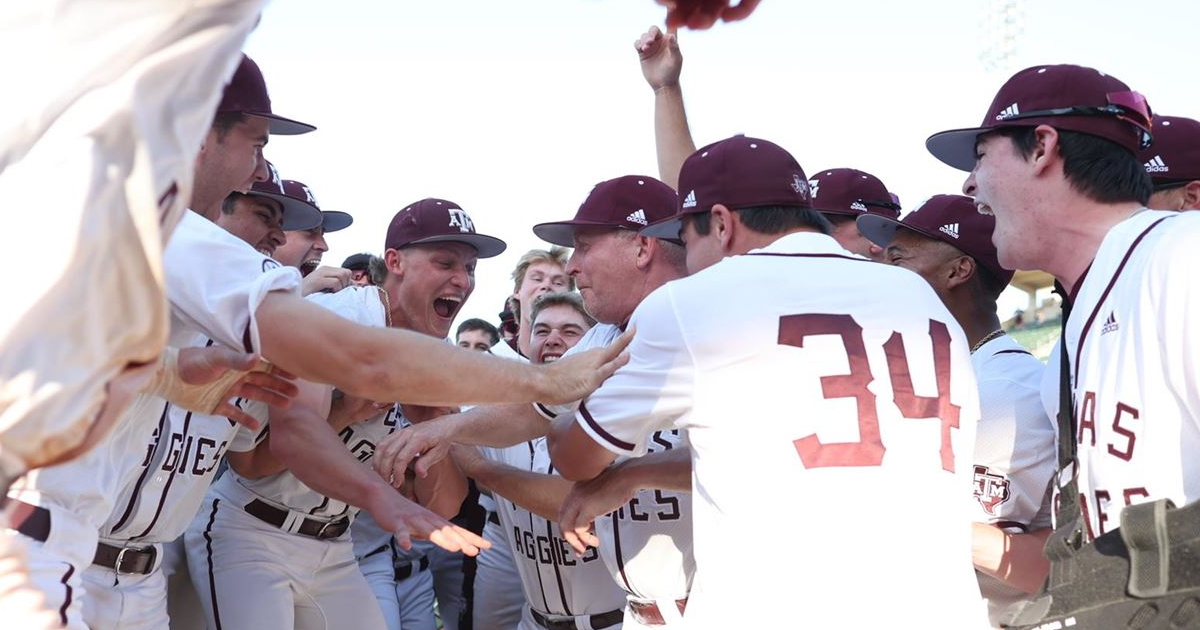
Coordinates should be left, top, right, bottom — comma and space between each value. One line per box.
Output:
1043, 210, 1200, 535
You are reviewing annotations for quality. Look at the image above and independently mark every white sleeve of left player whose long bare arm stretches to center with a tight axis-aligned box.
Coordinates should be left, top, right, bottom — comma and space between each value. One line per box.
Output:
163, 211, 300, 352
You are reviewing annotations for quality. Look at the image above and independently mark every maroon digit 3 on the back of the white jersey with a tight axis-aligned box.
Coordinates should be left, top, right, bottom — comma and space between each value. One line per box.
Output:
779, 314, 887, 468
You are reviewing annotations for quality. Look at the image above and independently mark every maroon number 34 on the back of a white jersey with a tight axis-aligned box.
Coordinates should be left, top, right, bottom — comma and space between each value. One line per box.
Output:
779, 314, 959, 473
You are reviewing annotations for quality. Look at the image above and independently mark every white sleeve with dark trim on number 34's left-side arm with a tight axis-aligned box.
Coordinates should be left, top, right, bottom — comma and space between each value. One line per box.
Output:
575, 286, 696, 457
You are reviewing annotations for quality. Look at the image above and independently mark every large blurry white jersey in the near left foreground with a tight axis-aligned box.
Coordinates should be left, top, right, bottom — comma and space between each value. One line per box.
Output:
0, 0, 265, 479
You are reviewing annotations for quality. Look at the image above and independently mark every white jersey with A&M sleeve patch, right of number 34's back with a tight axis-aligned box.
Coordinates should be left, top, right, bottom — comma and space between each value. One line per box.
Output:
971, 335, 1057, 628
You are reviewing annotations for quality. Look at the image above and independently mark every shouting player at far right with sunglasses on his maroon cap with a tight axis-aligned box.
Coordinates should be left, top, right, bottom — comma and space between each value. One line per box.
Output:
926, 65, 1200, 624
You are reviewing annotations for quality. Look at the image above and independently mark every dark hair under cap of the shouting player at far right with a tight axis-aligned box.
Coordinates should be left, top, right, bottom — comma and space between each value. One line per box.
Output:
995, 127, 1154, 205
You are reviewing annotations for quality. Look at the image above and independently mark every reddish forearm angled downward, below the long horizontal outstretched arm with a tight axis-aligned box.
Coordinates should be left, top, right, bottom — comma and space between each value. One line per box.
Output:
270, 407, 395, 508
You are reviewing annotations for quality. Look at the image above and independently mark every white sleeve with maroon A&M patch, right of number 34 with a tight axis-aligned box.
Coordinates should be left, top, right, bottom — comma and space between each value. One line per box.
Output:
973, 372, 1057, 530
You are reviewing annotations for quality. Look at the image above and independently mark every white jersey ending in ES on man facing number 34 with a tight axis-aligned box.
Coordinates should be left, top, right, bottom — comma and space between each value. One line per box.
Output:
535, 324, 696, 602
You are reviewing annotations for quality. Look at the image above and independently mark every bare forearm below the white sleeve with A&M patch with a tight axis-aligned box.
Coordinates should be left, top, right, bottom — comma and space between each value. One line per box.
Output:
971, 523, 1051, 593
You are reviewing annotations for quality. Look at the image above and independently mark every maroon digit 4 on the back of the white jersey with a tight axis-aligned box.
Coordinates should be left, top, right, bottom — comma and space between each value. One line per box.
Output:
883, 319, 961, 473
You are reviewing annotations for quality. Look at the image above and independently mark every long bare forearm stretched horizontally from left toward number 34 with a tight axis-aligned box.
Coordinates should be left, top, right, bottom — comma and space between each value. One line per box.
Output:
257, 292, 551, 406
